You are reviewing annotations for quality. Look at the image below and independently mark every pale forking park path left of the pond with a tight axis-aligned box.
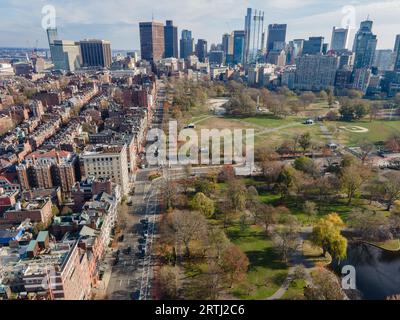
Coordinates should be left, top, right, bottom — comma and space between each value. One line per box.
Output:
266, 227, 315, 300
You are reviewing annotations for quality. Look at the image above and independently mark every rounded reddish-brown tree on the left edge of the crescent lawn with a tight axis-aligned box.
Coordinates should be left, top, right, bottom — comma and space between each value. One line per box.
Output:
221, 245, 249, 288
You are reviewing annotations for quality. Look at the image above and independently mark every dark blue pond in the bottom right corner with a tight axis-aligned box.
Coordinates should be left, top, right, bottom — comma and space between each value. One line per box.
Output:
340, 243, 400, 300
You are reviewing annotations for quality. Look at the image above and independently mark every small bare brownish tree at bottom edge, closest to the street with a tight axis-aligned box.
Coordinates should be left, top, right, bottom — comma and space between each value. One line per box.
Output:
158, 266, 181, 299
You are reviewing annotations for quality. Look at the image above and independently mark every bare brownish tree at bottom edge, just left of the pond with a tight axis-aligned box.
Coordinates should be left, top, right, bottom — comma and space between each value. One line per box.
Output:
304, 267, 345, 300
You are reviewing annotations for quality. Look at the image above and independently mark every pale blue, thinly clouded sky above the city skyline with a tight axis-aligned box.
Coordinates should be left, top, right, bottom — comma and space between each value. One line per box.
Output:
0, 0, 400, 50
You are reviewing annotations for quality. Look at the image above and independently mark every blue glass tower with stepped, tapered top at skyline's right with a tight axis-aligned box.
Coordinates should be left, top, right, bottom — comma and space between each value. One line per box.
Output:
353, 20, 378, 69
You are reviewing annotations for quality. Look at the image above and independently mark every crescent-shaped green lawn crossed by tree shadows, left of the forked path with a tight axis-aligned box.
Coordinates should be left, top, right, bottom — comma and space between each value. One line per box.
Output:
227, 225, 288, 300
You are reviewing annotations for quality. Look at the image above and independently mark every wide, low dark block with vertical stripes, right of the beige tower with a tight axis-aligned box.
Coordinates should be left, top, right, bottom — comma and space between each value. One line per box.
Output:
80, 39, 112, 68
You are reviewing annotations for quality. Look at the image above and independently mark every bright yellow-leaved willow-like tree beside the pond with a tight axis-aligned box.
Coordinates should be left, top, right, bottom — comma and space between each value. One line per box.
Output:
310, 213, 347, 260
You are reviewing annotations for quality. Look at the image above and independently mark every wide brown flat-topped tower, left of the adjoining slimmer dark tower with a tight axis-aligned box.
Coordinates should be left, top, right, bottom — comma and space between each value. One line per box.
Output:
139, 21, 165, 62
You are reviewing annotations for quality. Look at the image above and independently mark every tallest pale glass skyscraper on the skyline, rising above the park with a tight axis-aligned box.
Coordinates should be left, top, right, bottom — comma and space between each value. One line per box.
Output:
244, 8, 264, 63
